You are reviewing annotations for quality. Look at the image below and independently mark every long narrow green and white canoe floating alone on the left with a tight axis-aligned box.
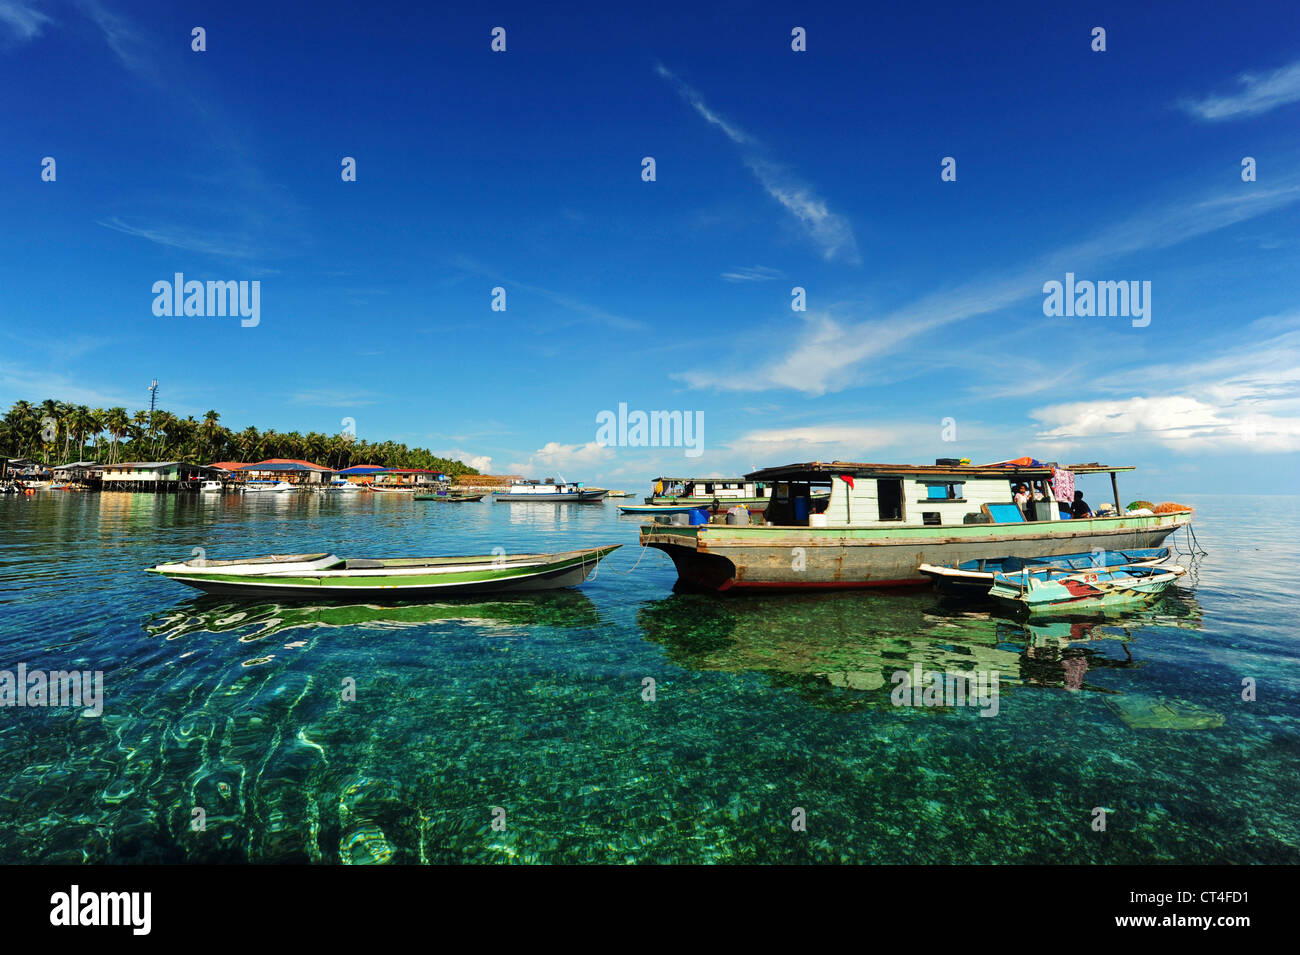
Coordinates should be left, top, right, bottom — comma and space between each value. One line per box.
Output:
148, 544, 620, 600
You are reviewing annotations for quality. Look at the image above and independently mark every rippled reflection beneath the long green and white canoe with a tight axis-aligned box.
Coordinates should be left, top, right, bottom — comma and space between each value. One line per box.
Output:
144, 590, 599, 643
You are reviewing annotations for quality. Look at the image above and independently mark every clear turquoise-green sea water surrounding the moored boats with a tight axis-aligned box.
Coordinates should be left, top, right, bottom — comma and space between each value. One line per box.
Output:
0, 492, 1300, 863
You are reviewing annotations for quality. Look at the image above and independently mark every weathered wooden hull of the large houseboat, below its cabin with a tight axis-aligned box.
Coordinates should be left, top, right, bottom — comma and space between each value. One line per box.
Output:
641, 512, 1192, 591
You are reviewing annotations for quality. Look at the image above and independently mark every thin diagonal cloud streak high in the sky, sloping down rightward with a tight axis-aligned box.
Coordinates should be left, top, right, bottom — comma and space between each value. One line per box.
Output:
655, 64, 861, 265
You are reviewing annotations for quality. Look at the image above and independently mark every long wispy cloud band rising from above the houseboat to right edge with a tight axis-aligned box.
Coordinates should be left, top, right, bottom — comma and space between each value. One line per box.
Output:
673, 181, 1300, 395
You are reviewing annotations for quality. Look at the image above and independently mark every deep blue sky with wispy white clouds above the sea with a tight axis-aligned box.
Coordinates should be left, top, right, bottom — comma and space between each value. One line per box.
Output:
0, 0, 1300, 499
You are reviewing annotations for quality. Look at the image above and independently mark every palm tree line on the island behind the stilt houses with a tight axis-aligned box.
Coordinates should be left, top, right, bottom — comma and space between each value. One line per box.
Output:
0, 399, 478, 477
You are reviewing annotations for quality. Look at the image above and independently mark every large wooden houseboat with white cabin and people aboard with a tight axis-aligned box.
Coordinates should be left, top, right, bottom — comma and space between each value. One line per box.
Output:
641, 461, 1192, 590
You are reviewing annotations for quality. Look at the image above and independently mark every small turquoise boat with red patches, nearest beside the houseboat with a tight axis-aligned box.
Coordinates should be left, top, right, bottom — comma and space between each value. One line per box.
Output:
988, 564, 1187, 613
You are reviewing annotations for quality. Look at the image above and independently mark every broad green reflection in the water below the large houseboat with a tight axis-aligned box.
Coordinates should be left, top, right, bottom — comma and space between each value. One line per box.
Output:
637, 591, 1199, 711
